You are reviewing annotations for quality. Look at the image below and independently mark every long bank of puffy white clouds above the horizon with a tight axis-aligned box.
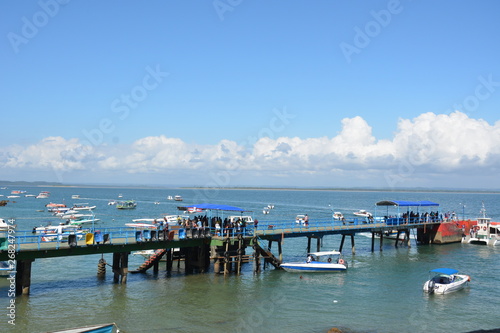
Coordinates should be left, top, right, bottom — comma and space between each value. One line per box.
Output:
0, 111, 500, 185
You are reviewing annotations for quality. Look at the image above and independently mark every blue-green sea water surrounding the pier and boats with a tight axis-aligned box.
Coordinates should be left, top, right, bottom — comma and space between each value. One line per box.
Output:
0, 187, 500, 333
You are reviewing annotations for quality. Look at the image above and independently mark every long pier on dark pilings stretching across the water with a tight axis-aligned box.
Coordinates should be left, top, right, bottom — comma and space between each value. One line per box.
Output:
0, 222, 442, 295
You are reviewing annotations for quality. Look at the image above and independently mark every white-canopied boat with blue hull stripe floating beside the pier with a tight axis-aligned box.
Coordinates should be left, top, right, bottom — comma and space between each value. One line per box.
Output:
280, 251, 347, 273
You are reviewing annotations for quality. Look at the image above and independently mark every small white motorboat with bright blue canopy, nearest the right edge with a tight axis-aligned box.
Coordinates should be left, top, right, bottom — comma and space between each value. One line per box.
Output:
424, 268, 470, 294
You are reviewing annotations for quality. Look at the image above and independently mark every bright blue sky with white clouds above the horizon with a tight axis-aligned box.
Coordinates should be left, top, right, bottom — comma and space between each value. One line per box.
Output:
0, 0, 500, 189
